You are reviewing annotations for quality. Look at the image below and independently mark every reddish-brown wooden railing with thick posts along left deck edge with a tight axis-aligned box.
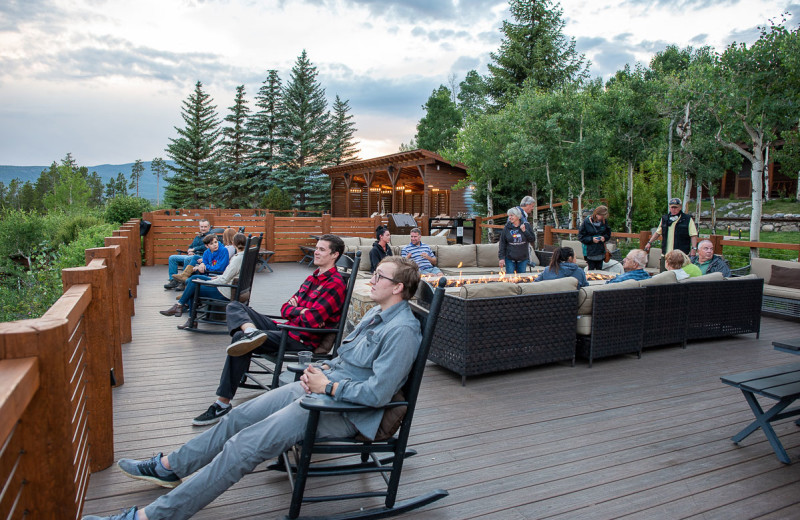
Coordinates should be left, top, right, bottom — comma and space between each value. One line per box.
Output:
0, 220, 141, 519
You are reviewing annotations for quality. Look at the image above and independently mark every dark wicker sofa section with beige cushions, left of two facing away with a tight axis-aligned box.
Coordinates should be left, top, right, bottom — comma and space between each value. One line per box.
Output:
428, 278, 578, 385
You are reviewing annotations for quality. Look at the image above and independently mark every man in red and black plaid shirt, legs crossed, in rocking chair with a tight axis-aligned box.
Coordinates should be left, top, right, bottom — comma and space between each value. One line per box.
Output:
192, 235, 347, 426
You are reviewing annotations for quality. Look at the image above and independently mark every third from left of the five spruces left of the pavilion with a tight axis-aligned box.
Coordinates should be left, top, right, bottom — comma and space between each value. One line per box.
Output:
245, 70, 283, 199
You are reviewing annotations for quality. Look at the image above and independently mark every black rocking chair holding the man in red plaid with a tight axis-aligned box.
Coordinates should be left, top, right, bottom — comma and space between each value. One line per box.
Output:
239, 251, 361, 390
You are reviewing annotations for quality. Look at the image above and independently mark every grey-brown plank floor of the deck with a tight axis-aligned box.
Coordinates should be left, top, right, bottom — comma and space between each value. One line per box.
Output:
84, 264, 800, 520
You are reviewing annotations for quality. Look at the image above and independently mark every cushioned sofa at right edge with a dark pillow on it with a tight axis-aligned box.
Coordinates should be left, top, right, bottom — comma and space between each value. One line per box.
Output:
750, 258, 800, 319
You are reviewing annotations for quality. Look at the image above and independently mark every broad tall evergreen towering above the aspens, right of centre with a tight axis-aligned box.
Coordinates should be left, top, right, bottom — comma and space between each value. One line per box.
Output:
486, 0, 588, 106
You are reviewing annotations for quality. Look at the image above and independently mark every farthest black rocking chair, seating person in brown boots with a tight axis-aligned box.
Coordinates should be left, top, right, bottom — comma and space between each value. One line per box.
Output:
185, 233, 263, 334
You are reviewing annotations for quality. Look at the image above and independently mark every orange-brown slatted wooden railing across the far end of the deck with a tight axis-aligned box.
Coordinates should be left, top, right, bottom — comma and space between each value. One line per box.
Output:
142, 210, 428, 265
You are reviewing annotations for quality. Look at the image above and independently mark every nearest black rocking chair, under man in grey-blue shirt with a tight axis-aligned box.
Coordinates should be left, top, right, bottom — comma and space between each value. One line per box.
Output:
276, 278, 448, 519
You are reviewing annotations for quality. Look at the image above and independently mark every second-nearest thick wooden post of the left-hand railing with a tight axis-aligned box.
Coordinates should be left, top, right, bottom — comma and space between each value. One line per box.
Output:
61, 259, 114, 472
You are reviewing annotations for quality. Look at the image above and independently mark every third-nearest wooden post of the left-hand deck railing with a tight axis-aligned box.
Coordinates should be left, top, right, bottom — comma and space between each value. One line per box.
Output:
86, 246, 124, 386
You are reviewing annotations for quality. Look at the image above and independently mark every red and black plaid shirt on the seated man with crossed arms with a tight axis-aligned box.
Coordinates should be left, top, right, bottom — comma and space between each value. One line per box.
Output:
281, 268, 347, 349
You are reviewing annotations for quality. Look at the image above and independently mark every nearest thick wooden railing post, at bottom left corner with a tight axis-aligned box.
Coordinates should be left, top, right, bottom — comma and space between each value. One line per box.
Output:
0, 314, 82, 518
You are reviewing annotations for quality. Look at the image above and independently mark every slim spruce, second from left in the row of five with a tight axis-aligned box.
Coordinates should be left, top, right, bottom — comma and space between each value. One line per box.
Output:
220, 85, 252, 208
